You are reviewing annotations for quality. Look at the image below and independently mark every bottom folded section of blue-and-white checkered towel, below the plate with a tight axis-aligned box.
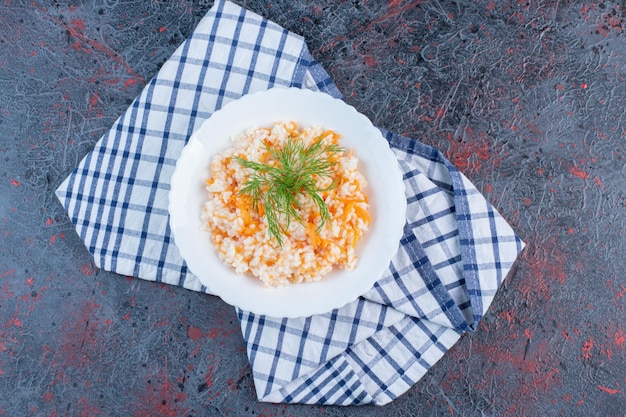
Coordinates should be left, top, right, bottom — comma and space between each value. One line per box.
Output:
239, 299, 461, 405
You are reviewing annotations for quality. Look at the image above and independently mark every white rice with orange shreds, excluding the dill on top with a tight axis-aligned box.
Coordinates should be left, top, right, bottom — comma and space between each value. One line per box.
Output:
201, 122, 370, 287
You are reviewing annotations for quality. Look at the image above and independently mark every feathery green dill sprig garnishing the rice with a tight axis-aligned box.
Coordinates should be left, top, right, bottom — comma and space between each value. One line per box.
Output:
233, 136, 343, 247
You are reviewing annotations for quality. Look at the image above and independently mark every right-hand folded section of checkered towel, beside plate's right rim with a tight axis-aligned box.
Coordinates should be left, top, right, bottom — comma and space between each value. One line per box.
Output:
364, 130, 524, 332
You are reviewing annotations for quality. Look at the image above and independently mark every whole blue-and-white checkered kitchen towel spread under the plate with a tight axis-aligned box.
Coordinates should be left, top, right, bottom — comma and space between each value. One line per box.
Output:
56, 1, 523, 405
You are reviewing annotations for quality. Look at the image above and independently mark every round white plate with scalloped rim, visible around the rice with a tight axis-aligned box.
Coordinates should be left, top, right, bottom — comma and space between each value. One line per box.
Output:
169, 88, 406, 318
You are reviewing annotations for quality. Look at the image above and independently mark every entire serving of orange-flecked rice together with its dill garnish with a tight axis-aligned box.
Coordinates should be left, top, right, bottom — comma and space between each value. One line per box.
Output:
201, 122, 370, 287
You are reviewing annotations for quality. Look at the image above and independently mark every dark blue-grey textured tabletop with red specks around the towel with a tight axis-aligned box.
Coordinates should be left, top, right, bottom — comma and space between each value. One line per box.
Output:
0, 0, 626, 416
